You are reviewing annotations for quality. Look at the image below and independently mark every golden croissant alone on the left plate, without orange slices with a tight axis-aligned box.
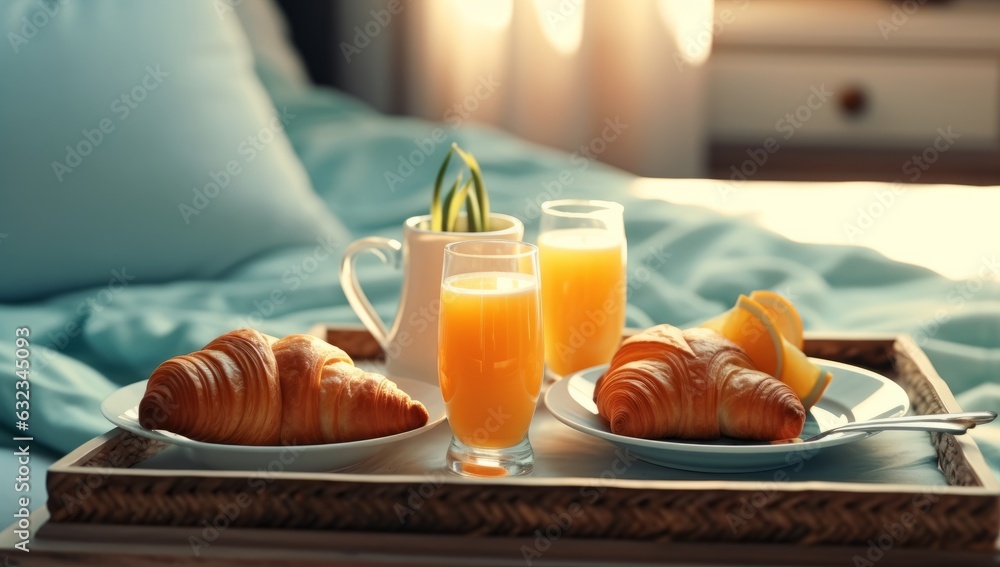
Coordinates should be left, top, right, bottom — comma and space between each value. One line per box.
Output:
139, 329, 429, 445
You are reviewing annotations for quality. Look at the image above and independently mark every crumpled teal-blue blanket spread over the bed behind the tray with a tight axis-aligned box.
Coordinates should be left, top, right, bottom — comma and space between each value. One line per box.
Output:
0, 85, 1000, 518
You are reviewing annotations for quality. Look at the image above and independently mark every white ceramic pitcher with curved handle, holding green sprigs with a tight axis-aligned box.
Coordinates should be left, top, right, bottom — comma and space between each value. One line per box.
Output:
340, 213, 524, 384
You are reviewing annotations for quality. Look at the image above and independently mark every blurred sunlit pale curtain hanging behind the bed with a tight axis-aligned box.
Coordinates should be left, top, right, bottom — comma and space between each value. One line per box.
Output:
337, 0, 713, 177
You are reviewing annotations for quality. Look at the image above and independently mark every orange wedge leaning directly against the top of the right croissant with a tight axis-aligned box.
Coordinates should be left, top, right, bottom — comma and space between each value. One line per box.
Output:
721, 295, 785, 377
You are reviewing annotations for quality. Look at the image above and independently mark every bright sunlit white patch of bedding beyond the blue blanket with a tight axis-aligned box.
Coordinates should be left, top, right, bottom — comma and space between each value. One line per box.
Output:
629, 178, 1000, 279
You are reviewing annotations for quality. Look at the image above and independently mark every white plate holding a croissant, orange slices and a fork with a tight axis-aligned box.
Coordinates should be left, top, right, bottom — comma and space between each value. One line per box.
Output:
545, 359, 910, 473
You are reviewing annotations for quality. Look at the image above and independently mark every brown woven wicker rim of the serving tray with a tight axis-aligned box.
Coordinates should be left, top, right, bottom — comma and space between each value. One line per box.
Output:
47, 328, 1000, 552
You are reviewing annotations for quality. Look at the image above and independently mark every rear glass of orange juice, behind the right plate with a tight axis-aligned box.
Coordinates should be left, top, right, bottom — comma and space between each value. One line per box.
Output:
538, 199, 626, 376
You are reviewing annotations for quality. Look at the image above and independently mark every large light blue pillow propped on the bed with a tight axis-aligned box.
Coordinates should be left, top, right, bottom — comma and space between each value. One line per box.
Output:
0, 0, 347, 302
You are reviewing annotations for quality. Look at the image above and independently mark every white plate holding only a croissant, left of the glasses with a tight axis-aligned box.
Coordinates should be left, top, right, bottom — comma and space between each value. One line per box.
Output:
101, 378, 445, 472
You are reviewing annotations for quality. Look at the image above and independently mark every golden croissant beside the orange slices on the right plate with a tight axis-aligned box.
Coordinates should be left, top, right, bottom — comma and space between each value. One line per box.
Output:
594, 325, 806, 441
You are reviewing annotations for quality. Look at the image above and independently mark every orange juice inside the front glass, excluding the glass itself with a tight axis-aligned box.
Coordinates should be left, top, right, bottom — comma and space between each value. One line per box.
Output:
438, 272, 544, 449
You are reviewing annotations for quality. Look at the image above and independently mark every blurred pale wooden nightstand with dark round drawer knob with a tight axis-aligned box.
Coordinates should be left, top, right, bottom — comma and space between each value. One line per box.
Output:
708, 0, 1000, 185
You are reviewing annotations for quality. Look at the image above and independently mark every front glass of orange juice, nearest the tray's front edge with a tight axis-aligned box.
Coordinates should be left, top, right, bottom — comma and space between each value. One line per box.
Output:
438, 240, 545, 476
